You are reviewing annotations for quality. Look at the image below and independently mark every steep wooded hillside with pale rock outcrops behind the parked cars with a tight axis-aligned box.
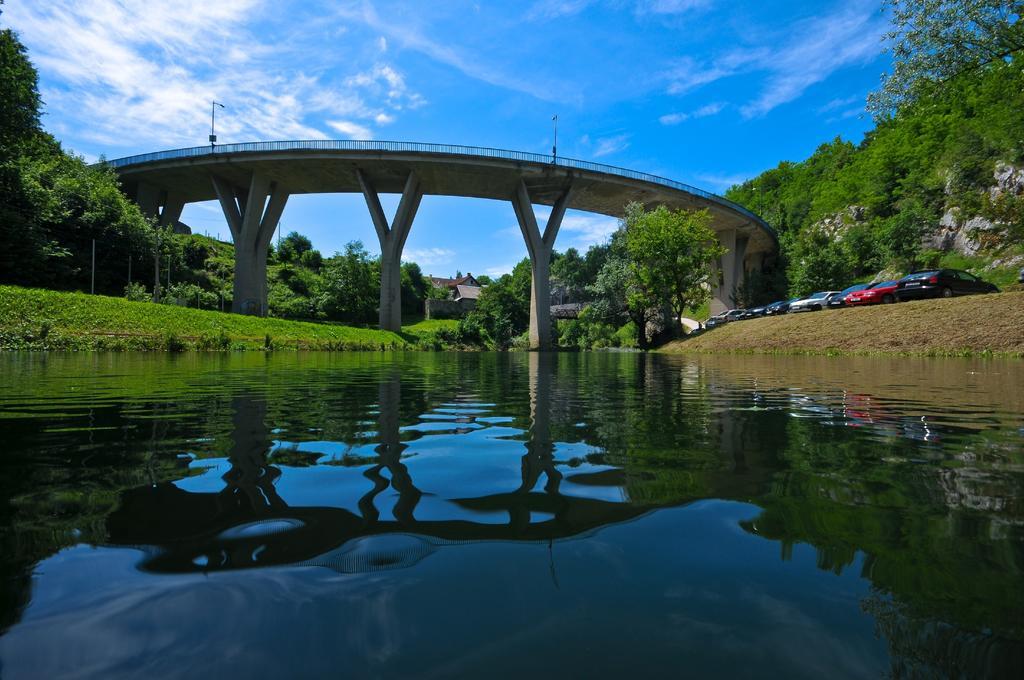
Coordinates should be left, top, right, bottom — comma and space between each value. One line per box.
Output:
726, 58, 1024, 306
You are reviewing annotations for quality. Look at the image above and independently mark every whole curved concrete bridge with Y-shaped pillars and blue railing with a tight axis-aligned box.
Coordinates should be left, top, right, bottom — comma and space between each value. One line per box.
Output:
110, 140, 777, 348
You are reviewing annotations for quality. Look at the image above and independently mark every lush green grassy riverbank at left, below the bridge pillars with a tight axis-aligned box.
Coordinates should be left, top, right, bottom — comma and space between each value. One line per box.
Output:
0, 286, 453, 351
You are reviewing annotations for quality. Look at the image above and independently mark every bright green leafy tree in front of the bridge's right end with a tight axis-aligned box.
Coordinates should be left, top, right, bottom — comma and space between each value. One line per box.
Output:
626, 204, 726, 333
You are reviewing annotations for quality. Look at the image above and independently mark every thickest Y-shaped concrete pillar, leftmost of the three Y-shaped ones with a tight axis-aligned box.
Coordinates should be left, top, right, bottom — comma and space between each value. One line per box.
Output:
213, 172, 288, 316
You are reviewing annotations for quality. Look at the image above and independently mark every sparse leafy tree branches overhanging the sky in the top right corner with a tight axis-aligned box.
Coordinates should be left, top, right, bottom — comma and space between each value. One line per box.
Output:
867, 0, 1024, 117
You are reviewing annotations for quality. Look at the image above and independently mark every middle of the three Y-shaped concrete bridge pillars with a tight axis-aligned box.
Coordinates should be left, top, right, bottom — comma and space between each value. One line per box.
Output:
355, 170, 423, 333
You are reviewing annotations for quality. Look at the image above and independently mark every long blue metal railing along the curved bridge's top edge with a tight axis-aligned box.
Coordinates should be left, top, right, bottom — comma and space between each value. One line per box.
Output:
106, 139, 774, 235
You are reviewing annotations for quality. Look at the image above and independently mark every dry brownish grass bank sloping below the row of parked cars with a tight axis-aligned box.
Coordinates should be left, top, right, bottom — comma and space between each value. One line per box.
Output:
663, 292, 1024, 356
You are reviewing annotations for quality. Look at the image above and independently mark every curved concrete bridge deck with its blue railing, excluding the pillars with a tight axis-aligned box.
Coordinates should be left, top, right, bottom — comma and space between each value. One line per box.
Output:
109, 140, 776, 252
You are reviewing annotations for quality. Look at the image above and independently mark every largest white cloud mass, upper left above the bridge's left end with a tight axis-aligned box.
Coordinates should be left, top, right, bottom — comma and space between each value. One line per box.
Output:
4, 0, 422, 146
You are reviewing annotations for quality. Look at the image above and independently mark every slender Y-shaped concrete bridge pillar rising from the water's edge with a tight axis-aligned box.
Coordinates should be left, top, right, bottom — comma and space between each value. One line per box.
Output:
512, 179, 572, 349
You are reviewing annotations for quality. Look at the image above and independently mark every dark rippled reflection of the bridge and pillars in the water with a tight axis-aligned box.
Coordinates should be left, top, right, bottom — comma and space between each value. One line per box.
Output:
108, 353, 651, 571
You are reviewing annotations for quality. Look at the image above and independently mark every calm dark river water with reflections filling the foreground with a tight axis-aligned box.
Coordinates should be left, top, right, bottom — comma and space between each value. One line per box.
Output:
0, 353, 1024, 678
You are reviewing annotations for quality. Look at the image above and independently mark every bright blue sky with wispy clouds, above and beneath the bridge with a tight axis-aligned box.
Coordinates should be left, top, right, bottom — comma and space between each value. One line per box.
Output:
6, 0, 888, 274
